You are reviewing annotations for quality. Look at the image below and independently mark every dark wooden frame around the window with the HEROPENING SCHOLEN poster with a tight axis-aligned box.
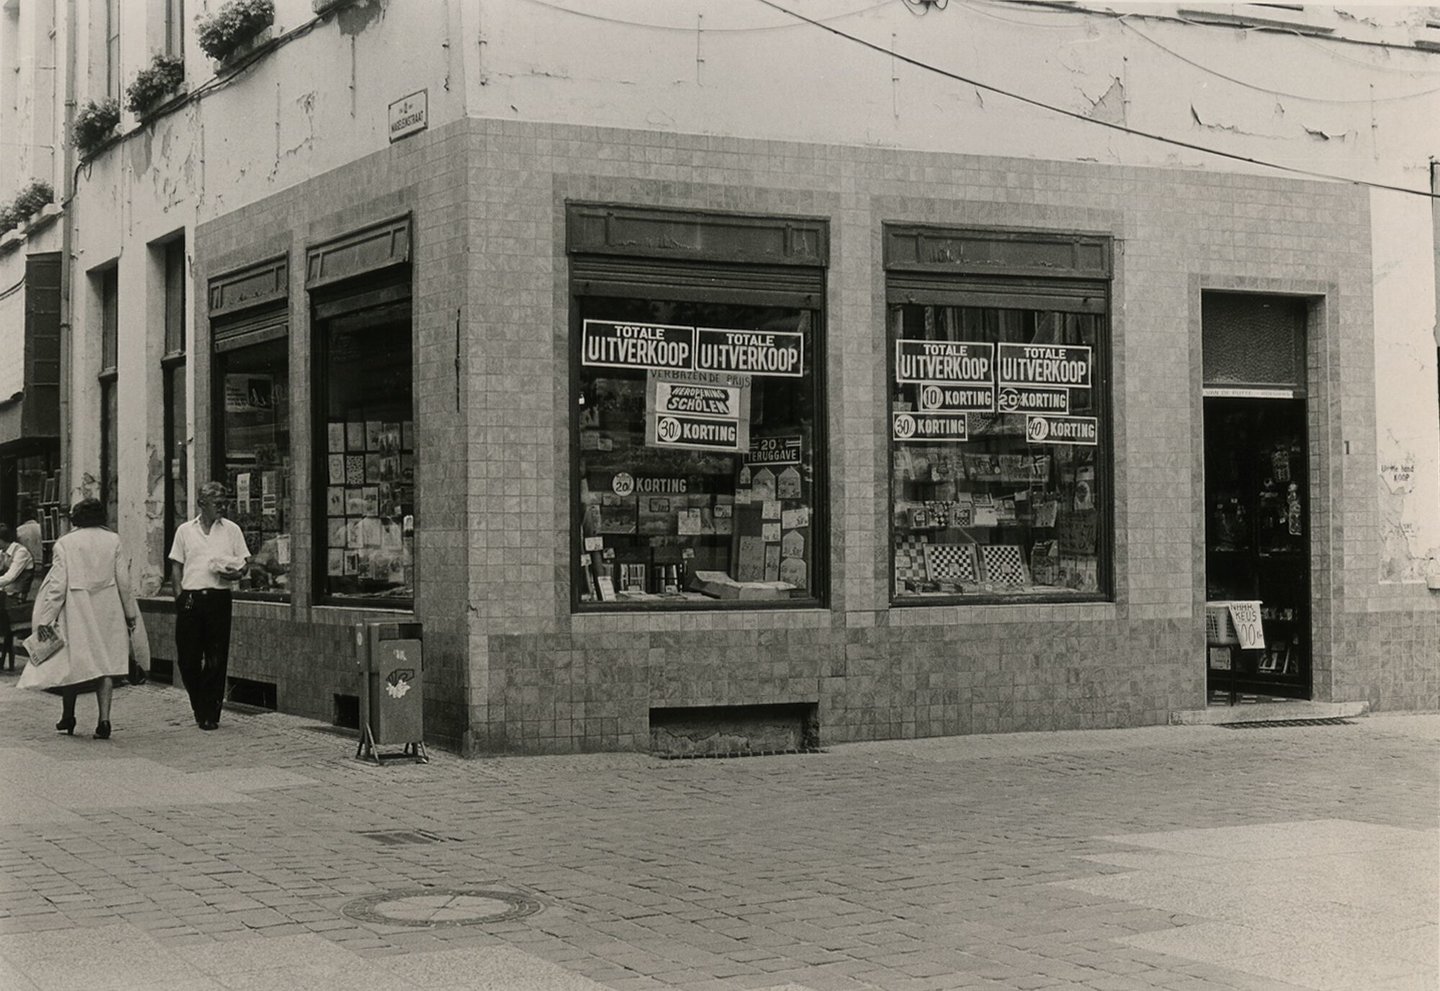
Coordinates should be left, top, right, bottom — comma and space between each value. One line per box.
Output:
563, 202, 832, 614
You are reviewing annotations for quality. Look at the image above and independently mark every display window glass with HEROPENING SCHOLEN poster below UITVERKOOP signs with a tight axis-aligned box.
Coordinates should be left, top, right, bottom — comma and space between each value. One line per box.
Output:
572, 297, 827, 608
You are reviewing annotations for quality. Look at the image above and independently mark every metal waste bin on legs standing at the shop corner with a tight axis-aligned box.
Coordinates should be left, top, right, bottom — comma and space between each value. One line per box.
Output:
354, 622, 429, 763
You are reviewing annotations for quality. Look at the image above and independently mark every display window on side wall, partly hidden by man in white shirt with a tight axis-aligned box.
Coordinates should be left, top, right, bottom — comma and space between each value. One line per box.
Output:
215, 336, 292, 596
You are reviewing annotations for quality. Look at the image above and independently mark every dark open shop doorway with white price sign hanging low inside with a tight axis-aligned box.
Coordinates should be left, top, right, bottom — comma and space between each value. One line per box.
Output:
1201, 292, 1313, 703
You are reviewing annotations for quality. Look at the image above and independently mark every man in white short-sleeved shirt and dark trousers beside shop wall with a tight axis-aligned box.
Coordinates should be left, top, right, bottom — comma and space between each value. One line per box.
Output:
170, 481, 251, 729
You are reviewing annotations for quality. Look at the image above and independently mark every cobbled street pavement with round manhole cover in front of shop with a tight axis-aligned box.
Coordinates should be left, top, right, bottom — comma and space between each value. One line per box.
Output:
0, 674, 1440, 991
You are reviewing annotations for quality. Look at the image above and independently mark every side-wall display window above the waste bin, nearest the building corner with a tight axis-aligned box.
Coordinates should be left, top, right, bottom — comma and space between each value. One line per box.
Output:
317, 300, 415, 604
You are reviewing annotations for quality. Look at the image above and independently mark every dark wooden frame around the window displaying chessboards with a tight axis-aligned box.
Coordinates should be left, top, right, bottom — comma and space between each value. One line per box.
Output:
881, 223, 1117, 609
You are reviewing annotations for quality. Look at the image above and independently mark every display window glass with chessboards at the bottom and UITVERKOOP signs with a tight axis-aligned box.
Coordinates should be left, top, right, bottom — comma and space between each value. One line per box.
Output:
888, 297, 1110, 602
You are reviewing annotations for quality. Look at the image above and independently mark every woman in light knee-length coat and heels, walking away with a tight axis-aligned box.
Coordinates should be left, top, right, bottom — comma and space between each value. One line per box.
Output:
19, 498, 140, 740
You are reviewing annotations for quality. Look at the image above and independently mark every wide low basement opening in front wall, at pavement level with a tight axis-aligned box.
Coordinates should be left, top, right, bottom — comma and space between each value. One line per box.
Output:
649, 703, 821, 761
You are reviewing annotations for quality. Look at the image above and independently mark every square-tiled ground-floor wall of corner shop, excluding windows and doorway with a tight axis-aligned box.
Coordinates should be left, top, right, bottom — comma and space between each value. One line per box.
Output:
140, 120, 1440, 753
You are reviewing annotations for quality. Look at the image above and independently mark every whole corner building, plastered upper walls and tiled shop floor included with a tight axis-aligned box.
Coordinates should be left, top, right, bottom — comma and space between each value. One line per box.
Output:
0, 0, 1440, 753
